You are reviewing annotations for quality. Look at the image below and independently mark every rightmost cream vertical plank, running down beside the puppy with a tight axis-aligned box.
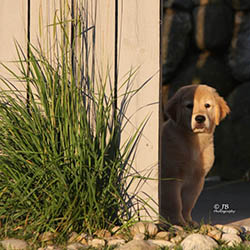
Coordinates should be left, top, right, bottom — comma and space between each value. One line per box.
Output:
118, 0, 160, 219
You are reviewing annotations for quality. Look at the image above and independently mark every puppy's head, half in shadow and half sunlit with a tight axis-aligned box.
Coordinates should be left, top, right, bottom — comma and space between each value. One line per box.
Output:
166, 85, 230, 133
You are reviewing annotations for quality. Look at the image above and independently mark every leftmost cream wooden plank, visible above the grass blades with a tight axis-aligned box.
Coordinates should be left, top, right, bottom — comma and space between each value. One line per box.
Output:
0, 0, 27, 90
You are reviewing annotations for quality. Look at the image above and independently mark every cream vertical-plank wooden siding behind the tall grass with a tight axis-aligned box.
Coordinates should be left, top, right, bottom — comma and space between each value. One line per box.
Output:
0, 0, 160, 217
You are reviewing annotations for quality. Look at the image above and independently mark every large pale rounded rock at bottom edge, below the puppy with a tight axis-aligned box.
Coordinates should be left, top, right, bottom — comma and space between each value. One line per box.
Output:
180, 234, 218, 250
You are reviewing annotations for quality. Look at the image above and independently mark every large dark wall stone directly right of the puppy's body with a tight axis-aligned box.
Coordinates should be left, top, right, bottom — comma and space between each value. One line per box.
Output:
214, 83, 250, 180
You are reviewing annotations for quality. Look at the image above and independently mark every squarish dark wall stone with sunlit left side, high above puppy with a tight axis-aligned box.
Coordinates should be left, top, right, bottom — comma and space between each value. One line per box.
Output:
193, 4, 233, 50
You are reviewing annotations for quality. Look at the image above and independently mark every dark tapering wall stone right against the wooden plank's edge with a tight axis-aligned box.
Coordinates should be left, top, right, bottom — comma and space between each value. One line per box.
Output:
162, 9, 192, 82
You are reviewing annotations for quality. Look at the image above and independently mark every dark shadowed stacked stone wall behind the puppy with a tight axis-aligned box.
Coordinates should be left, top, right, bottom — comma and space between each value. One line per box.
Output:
162, 0, 250, 179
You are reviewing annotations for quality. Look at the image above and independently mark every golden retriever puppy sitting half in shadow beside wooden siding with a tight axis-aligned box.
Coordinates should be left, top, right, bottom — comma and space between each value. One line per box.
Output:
160, 85, 230, 225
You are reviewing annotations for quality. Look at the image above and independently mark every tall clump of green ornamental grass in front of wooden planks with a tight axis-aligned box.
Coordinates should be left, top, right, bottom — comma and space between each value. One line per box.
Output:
0, 2, 148, 238
